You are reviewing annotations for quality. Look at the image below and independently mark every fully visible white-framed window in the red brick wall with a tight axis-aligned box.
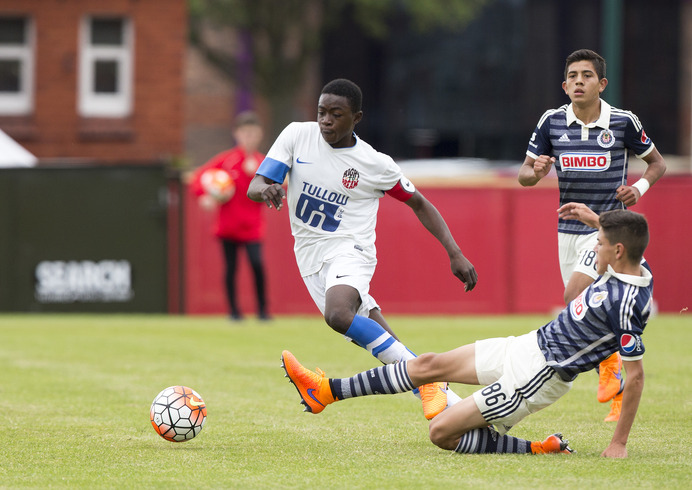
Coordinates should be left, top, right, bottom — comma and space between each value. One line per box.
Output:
79, 17, 133, 117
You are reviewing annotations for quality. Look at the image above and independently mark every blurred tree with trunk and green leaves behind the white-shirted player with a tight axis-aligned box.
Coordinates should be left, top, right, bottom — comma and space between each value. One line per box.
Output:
188, 0, 491, 134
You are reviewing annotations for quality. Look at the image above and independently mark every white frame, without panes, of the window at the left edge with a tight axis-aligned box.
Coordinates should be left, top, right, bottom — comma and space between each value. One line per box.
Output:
0, 17, 36, 116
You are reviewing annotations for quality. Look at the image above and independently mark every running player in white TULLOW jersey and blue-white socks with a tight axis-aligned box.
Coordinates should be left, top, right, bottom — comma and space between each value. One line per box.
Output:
248, 79, 478, 418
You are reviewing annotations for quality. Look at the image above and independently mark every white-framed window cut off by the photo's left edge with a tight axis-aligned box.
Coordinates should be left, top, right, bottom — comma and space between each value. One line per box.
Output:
0, 16, 34, 116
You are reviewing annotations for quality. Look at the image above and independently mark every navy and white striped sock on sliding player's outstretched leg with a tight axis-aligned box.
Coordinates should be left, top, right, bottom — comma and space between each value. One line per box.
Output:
329, 361, 415, 400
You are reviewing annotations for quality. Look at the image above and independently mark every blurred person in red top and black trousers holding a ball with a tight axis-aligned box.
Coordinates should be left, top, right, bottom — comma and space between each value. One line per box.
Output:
190, 112, 270, 320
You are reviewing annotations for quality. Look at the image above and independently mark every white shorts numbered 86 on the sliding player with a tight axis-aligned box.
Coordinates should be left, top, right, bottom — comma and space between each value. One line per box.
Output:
473, 330, 572, 435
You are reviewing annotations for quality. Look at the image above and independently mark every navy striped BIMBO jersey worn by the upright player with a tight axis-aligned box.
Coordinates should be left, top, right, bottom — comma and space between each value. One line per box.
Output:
526, 100, 654, 234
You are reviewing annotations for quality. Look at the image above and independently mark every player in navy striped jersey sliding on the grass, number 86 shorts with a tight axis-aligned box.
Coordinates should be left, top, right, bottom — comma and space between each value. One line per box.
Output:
282, 210, 653, 458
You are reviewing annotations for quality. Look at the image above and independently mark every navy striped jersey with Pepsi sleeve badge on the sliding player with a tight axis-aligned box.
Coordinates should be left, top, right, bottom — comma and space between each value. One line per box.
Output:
538, 266, 653, 381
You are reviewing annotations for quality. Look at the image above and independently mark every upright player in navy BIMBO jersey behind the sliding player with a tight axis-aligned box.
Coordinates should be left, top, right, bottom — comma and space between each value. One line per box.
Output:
518, 49, 666, 421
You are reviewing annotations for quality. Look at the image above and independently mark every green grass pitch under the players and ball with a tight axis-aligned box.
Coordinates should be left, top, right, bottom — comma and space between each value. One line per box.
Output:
0, 315, 692, 488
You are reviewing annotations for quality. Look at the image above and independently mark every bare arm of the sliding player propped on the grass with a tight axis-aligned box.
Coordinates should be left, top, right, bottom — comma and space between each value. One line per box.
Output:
601, 359, 644, 458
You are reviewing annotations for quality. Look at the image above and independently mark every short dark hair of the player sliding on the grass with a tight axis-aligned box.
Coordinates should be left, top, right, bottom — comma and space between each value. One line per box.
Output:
598, 209, 649, 263
